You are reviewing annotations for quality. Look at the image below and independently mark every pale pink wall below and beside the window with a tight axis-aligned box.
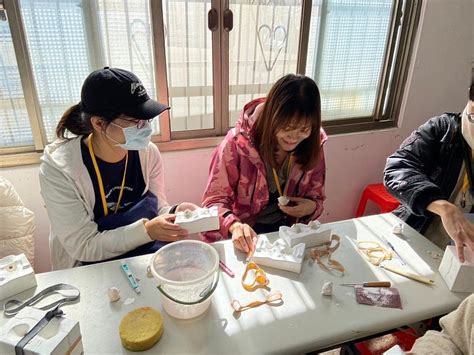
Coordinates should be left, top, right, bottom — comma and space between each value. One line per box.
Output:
0, 0, 474, 272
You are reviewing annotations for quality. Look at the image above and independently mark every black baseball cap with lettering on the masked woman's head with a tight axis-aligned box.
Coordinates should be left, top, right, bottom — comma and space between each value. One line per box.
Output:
79, 67, 169, 120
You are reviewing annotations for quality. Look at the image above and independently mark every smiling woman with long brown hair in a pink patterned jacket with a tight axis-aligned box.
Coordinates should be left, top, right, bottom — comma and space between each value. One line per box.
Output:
202, 74, 327, 252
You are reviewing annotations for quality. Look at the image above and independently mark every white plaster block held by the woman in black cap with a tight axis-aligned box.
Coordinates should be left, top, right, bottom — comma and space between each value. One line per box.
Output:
174, 206, 219, 234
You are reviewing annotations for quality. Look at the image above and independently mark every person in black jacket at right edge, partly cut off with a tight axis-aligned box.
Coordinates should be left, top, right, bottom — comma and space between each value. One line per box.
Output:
384, 82, 474, 262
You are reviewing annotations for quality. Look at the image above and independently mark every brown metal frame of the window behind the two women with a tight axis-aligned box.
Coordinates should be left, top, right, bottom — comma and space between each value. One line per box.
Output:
0, 0, 422, 167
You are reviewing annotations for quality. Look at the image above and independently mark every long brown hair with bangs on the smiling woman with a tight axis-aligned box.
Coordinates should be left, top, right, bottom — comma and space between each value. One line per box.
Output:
250, 74, 321, 170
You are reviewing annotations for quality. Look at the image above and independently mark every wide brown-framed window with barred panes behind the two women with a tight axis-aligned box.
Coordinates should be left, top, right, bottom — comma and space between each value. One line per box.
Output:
0, 0, 421, 167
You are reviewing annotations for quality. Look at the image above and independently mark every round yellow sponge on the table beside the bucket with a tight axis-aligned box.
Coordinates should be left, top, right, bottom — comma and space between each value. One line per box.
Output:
119, 307, 163, 351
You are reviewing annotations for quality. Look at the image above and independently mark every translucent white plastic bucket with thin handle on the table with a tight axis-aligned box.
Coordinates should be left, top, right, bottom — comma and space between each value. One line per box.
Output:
150, 240, 219, 319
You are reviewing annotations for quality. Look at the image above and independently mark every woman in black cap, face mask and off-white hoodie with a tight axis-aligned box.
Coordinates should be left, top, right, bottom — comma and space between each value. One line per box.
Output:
40, 67, 197, 269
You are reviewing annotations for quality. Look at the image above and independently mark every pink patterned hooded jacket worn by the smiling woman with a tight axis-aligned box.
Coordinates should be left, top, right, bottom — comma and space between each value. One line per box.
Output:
202, 98, 327, 242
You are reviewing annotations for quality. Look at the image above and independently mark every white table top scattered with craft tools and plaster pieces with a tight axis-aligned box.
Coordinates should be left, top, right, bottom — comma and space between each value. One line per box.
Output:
0, 214, 468, 354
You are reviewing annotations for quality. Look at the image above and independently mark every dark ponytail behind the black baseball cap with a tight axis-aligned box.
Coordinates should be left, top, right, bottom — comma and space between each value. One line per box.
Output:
56, 104, 93, 139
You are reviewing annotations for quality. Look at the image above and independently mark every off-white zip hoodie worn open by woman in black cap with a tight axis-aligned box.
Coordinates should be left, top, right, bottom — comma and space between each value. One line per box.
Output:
39, 137, 169, 270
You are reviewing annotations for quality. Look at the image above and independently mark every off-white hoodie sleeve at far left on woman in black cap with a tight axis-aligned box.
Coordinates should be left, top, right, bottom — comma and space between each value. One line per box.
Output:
40, 162, 151, 267
